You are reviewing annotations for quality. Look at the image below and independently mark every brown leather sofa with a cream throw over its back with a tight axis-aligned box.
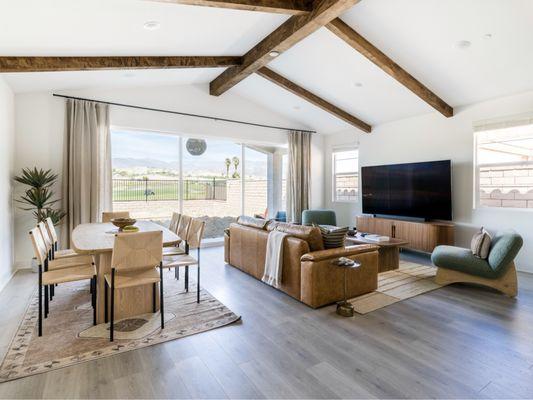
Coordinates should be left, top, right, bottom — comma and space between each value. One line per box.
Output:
224, 217, 378, 308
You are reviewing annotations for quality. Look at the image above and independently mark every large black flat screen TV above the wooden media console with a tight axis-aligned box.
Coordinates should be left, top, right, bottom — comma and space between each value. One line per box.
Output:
361, 160, 452, 220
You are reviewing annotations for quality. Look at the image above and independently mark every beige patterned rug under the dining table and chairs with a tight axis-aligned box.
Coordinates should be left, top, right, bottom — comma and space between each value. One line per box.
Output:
0, 271, 240, 382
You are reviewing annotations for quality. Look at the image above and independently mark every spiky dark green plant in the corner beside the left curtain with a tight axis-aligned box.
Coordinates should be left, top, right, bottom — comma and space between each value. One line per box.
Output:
14, 167, 66, 270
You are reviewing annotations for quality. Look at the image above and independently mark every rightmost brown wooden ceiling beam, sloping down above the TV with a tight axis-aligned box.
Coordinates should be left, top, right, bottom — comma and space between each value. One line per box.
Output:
326, 18, 453, 117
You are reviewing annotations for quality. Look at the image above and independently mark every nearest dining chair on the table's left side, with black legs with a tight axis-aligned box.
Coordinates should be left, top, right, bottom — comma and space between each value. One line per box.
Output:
30, 227, 96, 336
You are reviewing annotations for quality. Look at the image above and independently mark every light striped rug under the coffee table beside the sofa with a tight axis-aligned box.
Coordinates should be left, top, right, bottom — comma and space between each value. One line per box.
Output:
349, 261, 442, 314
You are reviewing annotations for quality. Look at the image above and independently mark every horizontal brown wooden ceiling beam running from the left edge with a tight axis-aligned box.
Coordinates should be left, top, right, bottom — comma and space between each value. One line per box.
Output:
0, 56, 242, 73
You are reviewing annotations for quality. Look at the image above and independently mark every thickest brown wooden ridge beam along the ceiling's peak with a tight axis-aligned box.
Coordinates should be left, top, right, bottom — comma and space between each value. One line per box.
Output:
209, 0, 360, 96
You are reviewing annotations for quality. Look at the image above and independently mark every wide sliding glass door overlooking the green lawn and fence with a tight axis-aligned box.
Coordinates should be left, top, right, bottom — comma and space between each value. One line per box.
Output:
111, 129, 281, 238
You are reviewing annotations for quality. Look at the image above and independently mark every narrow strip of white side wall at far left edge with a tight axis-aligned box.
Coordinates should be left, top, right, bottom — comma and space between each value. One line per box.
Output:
0, 77, 15, 290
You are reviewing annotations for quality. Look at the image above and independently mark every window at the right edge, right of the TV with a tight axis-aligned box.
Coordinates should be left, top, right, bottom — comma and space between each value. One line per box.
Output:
475, 124, 533, 209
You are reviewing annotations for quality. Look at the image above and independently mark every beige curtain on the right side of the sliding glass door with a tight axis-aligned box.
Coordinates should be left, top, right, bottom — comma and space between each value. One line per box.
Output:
287, 131, 311, 223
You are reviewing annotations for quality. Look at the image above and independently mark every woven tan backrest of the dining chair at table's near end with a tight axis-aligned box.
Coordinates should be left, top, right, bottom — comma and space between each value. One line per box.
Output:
111, 231, 163, 270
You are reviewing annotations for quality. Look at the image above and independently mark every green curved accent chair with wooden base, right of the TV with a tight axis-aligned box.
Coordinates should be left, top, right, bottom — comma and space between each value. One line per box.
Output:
431, 231, 524, 297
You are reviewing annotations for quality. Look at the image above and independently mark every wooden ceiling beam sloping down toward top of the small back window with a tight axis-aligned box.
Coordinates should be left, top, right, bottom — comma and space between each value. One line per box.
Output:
257, 67, 372, 133
